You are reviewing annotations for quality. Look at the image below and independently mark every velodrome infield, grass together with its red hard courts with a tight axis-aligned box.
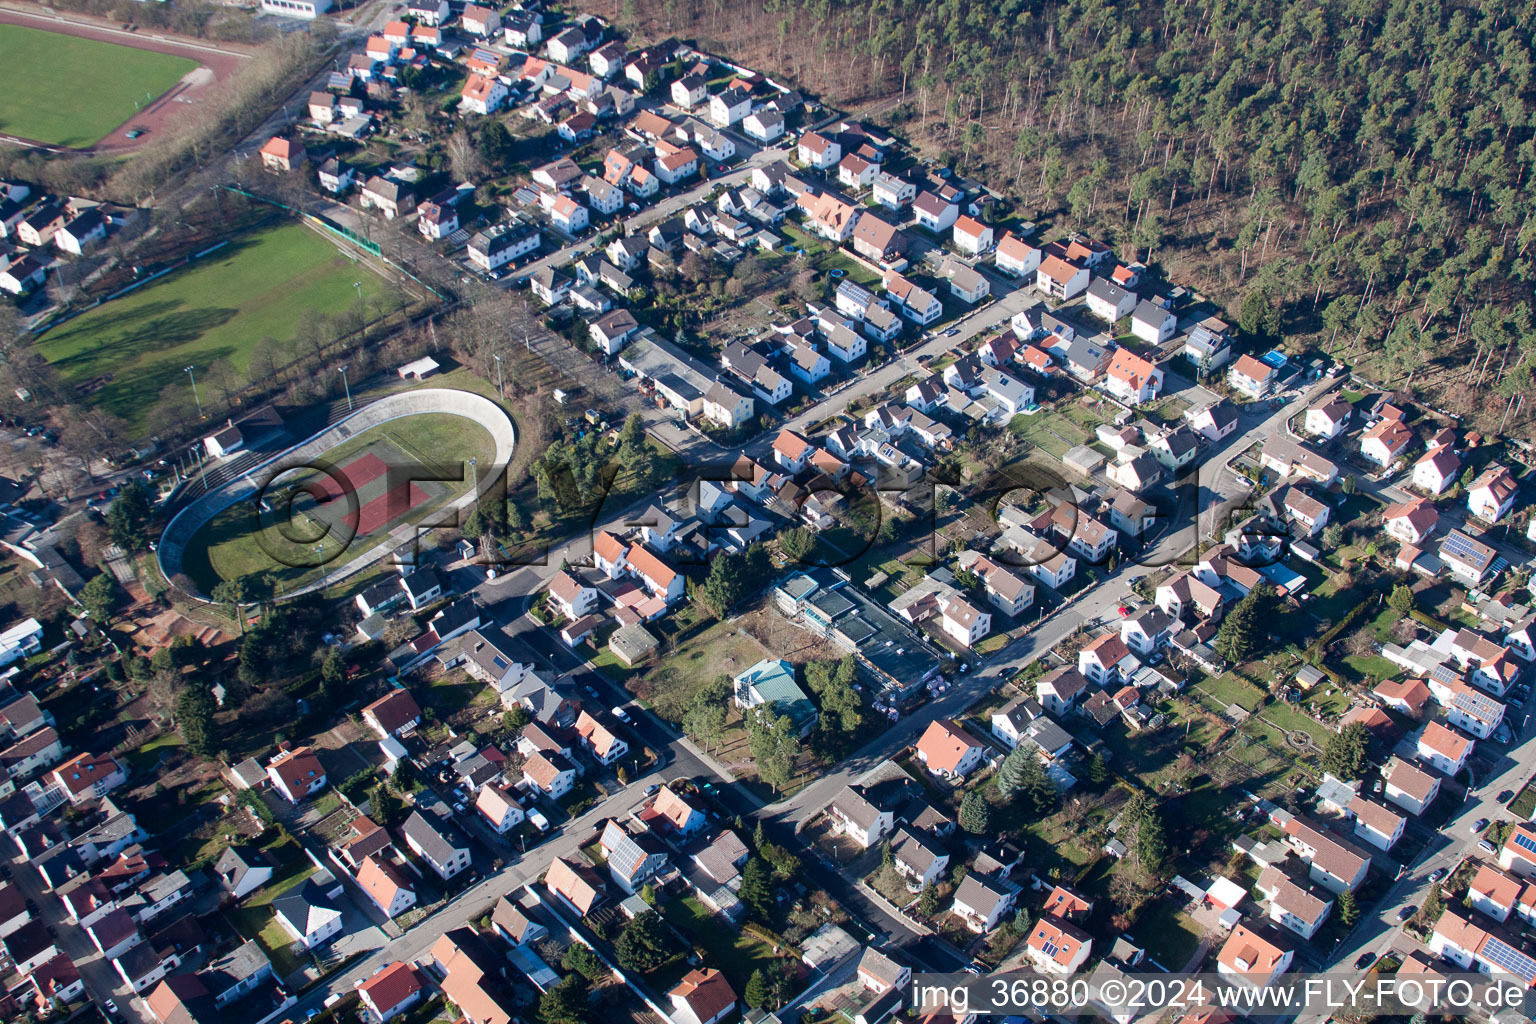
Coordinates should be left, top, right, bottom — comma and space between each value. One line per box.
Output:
181, 413, 496, 594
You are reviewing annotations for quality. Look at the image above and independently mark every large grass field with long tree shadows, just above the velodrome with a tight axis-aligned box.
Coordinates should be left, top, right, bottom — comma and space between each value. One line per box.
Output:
38, 222, 384, 427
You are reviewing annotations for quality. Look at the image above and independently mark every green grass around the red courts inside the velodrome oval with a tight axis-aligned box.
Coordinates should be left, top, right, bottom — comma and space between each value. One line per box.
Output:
181, 413, 496, 593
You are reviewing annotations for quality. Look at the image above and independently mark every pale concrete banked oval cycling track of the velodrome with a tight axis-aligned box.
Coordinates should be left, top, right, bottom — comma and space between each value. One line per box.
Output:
155, 387, 518, 602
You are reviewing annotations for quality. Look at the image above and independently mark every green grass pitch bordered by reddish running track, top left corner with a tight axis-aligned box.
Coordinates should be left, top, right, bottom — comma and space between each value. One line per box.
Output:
0, 25, 198, 149
